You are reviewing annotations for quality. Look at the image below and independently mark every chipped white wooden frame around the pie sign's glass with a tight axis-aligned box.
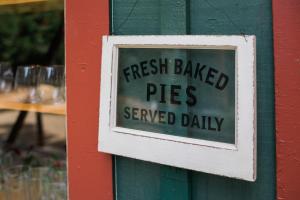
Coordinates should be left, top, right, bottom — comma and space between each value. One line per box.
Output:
98, 35, 256, 181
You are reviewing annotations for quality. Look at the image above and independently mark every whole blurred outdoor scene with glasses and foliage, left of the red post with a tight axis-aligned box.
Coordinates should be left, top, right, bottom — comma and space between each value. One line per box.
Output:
0, 0, 67, 200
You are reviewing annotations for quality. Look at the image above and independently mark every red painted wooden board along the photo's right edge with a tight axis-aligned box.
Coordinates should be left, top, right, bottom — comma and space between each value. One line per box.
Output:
273, 0, 300, 200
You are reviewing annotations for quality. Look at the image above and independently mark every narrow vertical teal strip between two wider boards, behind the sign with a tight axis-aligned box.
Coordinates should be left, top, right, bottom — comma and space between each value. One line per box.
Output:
160, 0, 190, 200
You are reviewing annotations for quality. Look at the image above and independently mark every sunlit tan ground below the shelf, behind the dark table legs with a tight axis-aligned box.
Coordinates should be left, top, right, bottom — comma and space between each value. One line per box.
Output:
0, 110, 66, 155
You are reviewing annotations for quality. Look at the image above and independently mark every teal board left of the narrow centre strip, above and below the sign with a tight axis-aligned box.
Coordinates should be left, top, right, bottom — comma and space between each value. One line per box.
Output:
111, 0, 161, 200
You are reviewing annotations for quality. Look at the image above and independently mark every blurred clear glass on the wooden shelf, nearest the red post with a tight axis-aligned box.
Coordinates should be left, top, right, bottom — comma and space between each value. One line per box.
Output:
38, 65, 65, 104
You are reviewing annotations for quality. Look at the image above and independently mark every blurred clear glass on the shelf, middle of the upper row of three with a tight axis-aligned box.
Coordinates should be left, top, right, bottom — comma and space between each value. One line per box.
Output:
15, 65, 40, 103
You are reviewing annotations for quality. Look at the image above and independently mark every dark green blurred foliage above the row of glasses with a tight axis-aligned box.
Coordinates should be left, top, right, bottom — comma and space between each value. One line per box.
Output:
0, 11, 64, 66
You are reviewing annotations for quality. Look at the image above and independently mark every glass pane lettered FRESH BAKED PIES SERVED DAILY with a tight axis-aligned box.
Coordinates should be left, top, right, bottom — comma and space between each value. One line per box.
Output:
116, 48, 235, 144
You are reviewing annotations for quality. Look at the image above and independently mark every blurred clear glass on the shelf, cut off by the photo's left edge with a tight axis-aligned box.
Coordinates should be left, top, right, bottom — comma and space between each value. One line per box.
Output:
0, 62, 14, 93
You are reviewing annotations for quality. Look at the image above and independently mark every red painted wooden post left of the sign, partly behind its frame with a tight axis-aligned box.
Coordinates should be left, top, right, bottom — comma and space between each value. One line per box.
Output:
65, 0, 113, 200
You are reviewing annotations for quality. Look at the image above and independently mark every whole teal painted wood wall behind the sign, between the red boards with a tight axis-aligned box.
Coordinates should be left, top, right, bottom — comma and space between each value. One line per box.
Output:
111, 0, 275, 200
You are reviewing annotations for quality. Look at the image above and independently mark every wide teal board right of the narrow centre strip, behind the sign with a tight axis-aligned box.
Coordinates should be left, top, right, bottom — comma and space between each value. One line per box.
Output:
190, 0, 276, 200
